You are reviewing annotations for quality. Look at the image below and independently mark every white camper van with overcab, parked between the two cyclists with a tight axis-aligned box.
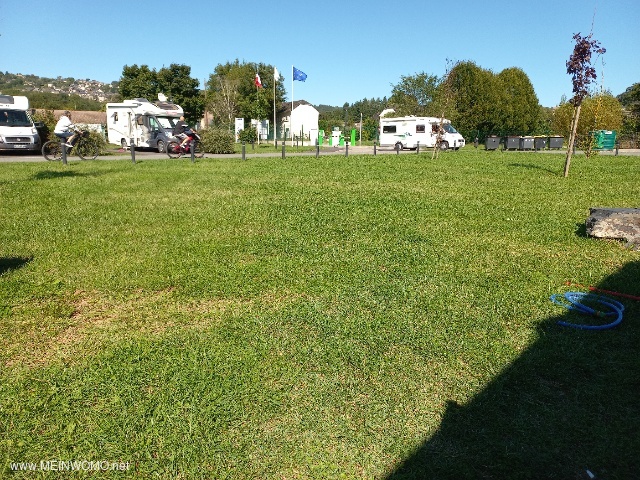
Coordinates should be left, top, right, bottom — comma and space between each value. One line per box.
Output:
107, 97, 184, 152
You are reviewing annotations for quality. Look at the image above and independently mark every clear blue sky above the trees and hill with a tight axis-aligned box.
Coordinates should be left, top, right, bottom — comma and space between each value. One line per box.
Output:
0, 0, 640, 107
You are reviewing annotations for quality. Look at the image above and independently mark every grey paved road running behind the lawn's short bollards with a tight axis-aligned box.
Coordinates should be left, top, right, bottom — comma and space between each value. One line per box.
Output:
0, 146, 640, 163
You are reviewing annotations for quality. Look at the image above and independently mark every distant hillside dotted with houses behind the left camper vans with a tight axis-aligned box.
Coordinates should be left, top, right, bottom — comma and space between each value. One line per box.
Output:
0, 72, 118, 110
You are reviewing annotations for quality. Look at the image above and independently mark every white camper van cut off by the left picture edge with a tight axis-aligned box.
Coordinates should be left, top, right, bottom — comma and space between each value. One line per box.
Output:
0, 94, 41, 151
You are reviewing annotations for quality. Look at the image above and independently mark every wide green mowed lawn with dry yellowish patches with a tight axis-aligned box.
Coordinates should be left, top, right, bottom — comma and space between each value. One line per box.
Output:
0, 148, 640, 480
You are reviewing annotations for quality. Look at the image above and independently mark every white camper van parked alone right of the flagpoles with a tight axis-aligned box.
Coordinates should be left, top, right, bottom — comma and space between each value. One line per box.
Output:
380, 116, 464, 150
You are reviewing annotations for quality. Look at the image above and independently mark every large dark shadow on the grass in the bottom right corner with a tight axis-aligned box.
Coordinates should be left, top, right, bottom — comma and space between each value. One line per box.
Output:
388, 261, 640, 480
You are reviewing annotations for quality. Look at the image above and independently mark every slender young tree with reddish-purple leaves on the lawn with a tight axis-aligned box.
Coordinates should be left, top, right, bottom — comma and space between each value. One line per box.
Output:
564, 32, 606, 177
